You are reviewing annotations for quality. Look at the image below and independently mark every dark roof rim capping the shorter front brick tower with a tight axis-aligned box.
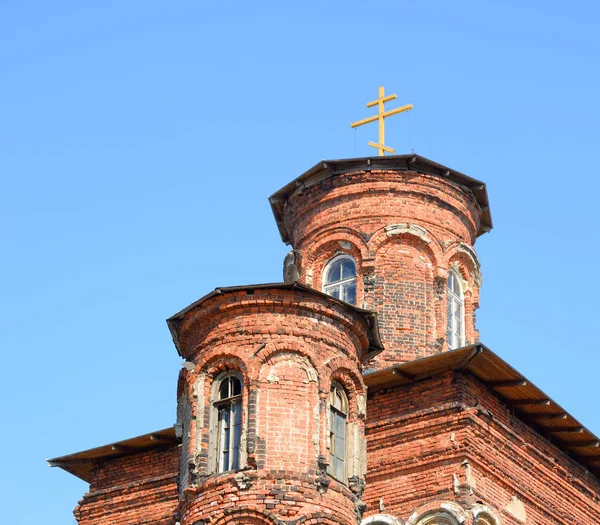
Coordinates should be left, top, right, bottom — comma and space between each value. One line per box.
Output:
167, 282, 383, 359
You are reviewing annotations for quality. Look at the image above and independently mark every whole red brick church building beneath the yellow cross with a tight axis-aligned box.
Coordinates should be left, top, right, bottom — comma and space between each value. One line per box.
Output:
50, 154, 600, 525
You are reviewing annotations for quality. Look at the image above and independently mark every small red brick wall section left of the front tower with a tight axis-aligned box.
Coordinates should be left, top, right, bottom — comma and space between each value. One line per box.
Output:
74, 447, 178, 525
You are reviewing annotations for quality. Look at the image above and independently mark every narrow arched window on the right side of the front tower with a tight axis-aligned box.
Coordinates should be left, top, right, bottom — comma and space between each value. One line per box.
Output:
328, 383, 349, 483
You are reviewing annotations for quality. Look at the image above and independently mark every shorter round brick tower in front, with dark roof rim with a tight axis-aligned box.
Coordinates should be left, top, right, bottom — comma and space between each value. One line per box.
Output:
169, 283, 382, 525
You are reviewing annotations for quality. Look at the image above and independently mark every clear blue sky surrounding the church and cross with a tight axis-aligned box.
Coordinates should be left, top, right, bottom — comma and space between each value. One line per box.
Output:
0, 0, 600, 525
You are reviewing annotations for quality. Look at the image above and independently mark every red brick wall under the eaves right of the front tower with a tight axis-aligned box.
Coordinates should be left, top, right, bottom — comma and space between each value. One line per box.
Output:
364, 372, 600, 525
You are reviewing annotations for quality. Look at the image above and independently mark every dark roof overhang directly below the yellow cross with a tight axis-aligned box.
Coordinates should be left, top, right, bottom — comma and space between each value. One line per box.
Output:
269, 153, 493, 244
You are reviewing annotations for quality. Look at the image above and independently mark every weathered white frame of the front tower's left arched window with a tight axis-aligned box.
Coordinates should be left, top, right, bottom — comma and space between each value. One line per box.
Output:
210, 370, 244, 473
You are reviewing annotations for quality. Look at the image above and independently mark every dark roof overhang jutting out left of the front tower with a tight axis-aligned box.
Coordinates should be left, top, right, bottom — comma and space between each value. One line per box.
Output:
46, 427, 179, 483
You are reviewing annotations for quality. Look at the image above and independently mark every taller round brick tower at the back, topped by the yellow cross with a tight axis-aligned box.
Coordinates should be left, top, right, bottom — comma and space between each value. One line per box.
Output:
269, 154, 492, 368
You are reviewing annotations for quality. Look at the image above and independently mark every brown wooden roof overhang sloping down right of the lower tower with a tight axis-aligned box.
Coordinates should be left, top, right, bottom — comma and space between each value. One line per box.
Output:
363, 344, 600, 478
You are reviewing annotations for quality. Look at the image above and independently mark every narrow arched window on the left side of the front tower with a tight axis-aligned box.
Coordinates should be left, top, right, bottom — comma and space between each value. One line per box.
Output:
212, 372, 242, 472
